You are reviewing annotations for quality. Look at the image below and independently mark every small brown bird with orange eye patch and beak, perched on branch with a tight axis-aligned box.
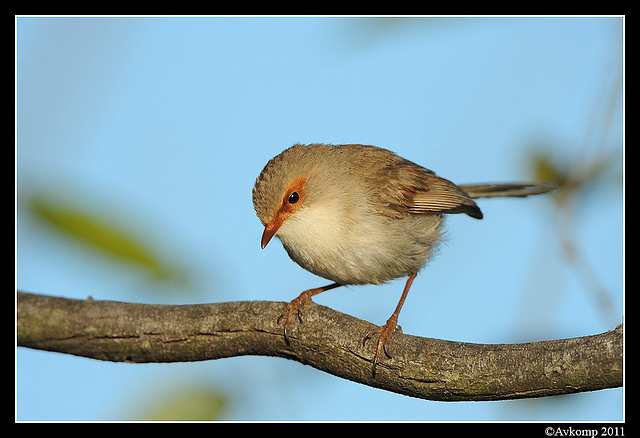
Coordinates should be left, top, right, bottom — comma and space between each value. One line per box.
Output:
253, 144, 554, 372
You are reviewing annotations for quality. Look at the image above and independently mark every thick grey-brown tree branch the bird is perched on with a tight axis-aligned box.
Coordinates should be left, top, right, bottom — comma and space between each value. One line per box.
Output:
17, 292, 623, 401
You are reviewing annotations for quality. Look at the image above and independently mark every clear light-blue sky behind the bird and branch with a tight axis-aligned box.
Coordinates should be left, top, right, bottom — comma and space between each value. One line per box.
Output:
16, 17, 624, 421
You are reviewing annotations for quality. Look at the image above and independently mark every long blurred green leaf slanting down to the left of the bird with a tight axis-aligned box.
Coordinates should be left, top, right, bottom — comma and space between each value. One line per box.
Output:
27, 195, 178, 281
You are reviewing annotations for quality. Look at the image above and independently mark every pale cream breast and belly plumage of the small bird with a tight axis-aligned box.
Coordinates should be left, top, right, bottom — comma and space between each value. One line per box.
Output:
277, 200, 441, 285
